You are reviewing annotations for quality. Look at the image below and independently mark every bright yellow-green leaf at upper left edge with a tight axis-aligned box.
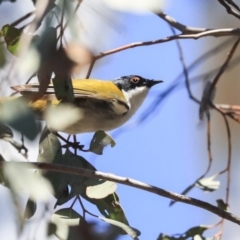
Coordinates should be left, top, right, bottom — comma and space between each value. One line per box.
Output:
1, 24, 22, 56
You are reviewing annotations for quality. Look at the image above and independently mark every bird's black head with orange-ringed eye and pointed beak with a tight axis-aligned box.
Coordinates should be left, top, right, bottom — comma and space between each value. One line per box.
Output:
113, 75, 163, 91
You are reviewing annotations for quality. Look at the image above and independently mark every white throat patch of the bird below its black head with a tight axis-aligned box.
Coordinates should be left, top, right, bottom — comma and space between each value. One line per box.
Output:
122, 86, 149, 117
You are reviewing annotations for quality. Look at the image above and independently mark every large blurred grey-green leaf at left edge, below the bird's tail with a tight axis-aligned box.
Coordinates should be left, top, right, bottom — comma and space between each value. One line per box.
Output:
0, 97, 40, 140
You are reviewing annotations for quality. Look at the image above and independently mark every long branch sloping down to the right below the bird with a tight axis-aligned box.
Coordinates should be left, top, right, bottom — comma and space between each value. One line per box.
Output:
0, 161, 240, 225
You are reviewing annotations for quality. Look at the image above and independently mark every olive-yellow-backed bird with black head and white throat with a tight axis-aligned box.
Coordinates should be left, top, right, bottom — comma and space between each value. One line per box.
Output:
8, 75, 163, 134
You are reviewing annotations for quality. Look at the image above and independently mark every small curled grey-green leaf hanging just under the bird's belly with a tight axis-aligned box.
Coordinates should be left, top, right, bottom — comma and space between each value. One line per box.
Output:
89, 130, 116, 155
